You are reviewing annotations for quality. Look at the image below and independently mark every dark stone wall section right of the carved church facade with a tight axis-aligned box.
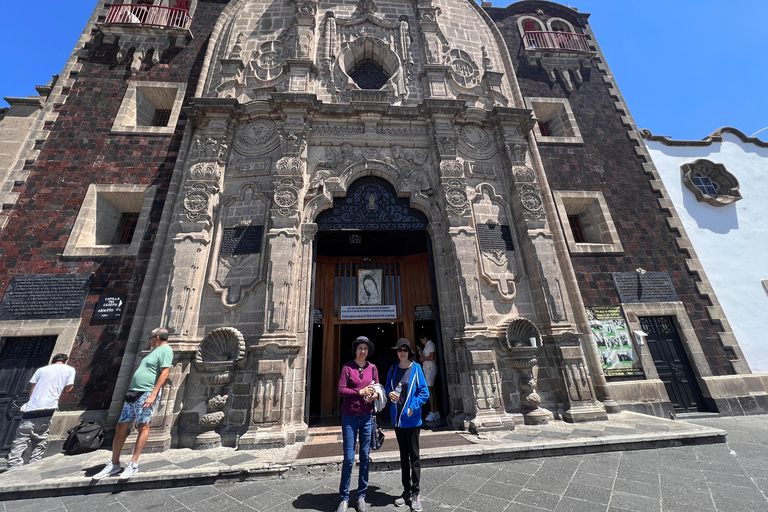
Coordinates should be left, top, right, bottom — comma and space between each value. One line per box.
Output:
488, 2, 734, 375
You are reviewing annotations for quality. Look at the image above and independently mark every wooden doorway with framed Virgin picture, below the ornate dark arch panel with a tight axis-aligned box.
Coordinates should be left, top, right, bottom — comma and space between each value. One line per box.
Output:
309, 252, 436, 421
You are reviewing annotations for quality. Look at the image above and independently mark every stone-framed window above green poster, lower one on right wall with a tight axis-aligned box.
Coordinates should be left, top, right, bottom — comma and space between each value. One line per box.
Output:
553, 190, 624, 254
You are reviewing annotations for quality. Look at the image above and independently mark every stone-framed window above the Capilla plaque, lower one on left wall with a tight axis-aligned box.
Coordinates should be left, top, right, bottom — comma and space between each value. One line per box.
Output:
63, 185, 157, 257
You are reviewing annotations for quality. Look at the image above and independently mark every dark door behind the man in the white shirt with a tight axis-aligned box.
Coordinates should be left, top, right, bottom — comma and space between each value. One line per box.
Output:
0, 336, 56, 457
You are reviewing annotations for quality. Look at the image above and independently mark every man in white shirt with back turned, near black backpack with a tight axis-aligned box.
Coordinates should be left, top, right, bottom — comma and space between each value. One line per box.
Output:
8, 354, 75, 471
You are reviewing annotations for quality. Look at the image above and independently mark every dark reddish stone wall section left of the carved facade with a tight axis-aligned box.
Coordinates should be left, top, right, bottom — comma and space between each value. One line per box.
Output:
0, 0, 224, 410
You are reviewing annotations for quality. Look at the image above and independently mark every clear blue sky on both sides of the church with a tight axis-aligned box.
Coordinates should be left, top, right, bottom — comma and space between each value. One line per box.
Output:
0, 0, 768, 140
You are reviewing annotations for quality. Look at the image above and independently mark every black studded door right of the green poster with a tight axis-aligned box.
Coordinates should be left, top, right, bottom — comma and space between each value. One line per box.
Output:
640, 316, 706, 412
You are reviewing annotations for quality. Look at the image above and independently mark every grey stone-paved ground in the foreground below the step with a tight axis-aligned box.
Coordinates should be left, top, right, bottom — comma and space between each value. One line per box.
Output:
0, 416, 768, 512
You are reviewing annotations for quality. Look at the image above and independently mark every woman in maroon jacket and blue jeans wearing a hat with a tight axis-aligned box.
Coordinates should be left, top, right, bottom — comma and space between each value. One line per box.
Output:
336, 336, 379, 512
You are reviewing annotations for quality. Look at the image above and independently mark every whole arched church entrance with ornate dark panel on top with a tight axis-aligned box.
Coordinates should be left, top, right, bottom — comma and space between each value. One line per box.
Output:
307, 176, 444, 425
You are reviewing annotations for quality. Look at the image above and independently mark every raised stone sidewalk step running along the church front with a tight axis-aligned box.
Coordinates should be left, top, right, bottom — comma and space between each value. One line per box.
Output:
0, 412, 726, 500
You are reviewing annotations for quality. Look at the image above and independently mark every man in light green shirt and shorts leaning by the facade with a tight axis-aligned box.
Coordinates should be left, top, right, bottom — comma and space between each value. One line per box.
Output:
93, 329, 173, 480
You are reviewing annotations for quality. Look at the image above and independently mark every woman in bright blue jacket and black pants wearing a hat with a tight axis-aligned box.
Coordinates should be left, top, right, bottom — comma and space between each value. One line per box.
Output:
385, 338, 429, 512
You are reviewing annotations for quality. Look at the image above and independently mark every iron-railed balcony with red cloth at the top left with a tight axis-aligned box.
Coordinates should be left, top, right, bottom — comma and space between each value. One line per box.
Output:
98, 2, 192, 37
